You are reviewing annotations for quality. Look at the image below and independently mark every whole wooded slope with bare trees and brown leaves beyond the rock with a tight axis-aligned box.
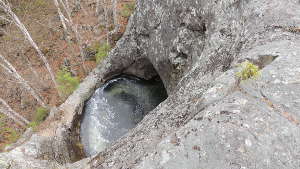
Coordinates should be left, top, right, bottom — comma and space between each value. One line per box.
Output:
0, 0, 135, 151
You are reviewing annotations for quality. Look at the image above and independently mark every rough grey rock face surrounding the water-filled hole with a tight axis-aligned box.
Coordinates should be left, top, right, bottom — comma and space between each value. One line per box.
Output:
0, 0, 300, 169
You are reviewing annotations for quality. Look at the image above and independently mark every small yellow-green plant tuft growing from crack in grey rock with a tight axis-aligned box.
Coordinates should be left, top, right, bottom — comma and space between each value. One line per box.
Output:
237, 61, 260, 80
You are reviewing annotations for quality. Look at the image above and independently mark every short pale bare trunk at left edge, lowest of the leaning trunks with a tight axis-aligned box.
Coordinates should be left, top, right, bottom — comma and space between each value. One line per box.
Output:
0, 98, 29, 127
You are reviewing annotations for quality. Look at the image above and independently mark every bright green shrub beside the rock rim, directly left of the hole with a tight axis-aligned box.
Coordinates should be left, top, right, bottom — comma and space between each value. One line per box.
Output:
56, 68, 80, 96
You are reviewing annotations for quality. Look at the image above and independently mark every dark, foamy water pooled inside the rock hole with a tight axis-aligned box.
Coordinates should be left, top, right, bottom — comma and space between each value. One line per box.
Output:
80, 76, 167, 156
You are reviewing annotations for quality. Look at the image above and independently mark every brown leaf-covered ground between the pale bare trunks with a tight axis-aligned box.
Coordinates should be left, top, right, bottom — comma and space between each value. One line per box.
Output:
0, 0, 134, 151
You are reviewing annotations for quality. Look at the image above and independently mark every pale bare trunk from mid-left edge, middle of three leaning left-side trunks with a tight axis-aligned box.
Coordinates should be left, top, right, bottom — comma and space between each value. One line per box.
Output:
0, 55, 47, 108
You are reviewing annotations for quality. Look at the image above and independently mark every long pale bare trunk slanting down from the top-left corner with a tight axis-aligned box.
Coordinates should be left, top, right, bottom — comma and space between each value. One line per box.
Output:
0, 0, 58, 91
